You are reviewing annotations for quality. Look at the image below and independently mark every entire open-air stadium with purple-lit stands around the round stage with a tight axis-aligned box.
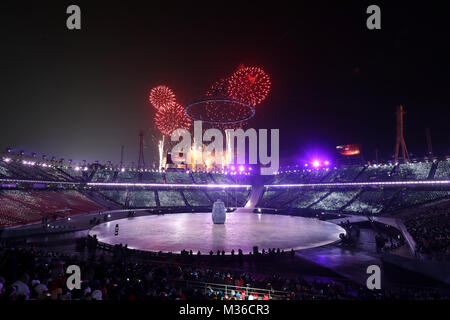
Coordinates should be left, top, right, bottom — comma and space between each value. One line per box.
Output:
0, 151, 450, 300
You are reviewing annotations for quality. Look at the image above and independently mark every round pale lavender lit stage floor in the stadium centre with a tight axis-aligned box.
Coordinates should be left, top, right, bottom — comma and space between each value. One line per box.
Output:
89, 212, 345, 254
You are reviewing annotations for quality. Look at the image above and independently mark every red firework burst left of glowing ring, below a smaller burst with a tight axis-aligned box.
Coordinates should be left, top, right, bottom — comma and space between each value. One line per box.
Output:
155, 103, 192, 136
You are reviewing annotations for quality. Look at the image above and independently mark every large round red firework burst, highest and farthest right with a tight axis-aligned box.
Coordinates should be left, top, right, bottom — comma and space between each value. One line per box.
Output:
228, 67, 271, 106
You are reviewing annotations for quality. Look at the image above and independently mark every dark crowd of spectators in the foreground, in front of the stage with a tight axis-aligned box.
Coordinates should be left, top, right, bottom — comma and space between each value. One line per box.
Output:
0, 247, 448, 301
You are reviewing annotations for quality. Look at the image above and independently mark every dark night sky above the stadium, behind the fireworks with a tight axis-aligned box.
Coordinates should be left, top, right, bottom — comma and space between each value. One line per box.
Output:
0, 0, 450, 168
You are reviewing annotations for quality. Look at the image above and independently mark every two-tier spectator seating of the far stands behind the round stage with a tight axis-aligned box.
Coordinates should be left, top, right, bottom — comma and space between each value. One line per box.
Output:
0, 160, 450, 225
